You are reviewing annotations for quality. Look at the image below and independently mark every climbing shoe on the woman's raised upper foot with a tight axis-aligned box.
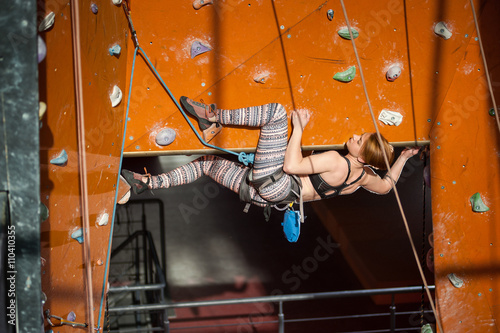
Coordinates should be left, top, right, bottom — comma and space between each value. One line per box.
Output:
181, 96, 222, 142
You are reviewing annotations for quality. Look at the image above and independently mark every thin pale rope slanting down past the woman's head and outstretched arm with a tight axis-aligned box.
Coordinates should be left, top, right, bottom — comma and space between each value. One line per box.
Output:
340, 0, 444, 332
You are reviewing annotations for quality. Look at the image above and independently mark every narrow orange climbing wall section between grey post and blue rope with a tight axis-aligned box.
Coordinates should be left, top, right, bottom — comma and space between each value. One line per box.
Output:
38, 1, 128, 333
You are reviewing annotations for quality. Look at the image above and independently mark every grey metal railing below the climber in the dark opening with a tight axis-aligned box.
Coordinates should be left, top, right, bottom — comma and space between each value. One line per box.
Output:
108, 286, 435, 333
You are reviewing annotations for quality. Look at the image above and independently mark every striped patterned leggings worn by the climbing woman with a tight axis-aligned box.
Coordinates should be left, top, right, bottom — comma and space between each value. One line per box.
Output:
151, 103, 291, 206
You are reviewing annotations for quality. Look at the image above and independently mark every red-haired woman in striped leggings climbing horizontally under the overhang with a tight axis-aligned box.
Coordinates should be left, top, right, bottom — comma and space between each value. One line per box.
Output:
122, 97, 418, 206
